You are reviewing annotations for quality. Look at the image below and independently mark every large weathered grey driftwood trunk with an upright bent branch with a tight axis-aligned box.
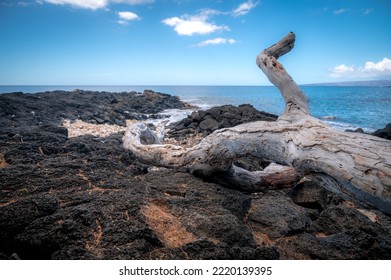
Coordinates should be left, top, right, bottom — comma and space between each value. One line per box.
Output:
123, 32, 391, 214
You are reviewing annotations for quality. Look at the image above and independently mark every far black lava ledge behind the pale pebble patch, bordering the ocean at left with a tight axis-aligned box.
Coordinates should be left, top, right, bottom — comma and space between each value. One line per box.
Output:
0, 90, 187, 131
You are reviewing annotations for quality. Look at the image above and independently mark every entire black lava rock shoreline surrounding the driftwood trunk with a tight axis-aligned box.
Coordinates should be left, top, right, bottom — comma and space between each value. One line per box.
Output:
0, 90, 391, 259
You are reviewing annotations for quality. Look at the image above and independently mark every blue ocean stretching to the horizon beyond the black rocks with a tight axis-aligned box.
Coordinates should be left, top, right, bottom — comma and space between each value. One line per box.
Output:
0, 86, 391, 132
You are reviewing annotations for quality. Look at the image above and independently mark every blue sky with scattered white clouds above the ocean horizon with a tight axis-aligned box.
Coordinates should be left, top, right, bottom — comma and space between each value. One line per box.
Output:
0, 0, 391, 85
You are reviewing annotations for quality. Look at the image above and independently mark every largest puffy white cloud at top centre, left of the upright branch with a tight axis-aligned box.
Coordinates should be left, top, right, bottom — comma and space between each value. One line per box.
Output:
162, 10, 229, 36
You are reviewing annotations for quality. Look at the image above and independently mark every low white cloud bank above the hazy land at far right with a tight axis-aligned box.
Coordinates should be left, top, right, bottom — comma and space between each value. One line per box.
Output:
330, 57, 391, 79
